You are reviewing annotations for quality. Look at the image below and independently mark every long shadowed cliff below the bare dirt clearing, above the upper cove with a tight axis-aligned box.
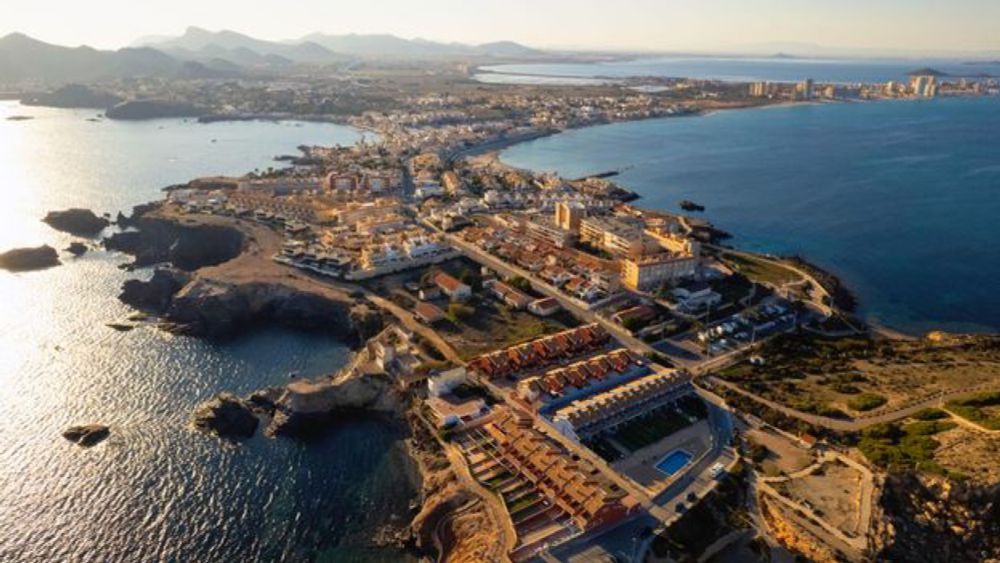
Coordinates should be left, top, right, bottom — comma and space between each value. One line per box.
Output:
165, 278, 382, 343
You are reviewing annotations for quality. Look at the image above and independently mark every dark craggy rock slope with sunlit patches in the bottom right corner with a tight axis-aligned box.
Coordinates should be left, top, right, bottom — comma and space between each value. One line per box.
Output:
876, 474, 1000, 563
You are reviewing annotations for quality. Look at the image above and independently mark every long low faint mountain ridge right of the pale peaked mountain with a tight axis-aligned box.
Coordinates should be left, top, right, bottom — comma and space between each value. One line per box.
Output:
300, 33, 544, 59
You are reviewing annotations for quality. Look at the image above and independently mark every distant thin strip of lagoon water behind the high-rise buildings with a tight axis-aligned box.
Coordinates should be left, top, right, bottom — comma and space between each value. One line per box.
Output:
477, 56, 1000, 84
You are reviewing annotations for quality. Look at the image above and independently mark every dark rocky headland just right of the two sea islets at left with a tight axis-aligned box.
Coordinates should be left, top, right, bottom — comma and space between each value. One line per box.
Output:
104, 217, 244, 272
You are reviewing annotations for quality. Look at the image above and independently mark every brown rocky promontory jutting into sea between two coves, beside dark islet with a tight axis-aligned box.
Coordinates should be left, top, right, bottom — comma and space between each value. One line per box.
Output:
267, 375, 400, 436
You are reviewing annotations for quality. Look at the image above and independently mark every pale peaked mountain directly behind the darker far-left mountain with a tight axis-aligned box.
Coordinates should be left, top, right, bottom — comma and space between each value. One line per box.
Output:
145, 27, 347, 66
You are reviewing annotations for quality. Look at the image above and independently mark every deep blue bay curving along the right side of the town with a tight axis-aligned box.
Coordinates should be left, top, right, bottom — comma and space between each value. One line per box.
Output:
502, 98, 1000, 333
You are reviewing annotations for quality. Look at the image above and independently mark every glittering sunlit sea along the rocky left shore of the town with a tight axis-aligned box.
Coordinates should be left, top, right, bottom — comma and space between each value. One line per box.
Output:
0, 102, 415, 563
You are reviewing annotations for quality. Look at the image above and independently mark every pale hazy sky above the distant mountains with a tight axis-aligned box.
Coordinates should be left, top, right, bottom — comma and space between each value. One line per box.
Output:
0, 0, 1000, 52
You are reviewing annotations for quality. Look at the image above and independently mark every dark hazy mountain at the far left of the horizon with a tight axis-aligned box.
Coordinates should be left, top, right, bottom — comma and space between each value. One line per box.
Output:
0, 33, 230, 84
